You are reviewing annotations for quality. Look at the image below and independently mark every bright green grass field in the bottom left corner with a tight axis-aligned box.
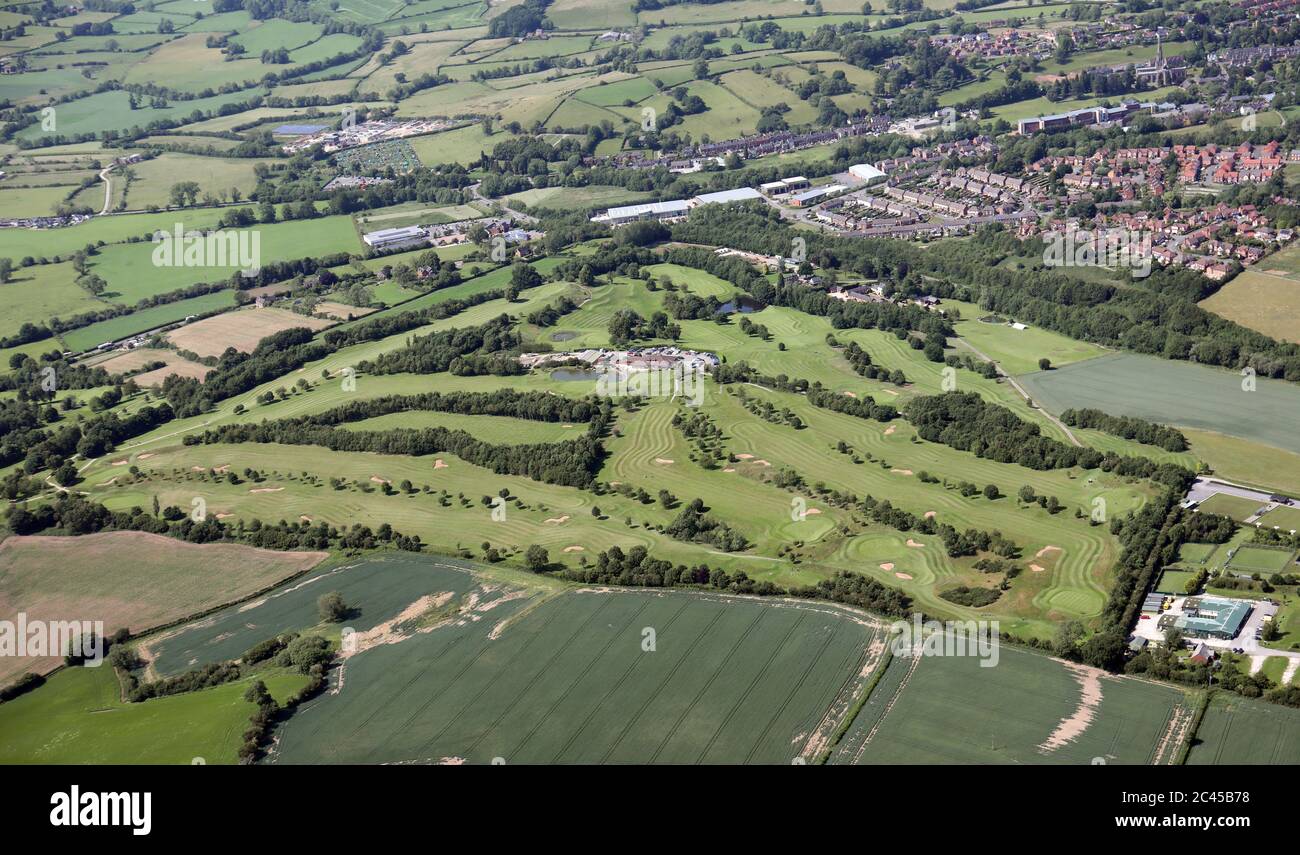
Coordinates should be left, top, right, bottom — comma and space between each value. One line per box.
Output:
0, 654, 307, 765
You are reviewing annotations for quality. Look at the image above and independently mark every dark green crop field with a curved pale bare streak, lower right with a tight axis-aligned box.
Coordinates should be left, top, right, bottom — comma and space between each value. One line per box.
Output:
832, 644, 1191, 765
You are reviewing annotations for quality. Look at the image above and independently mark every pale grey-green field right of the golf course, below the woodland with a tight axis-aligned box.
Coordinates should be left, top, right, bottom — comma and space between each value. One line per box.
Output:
1021, 353, 1300, 453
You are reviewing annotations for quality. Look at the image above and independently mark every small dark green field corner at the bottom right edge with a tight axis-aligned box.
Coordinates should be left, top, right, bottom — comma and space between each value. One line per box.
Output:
1187, 691, 1300, 765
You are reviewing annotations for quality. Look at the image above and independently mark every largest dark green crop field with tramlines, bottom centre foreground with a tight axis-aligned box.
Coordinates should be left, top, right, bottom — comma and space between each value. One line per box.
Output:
144, 556, 894, 763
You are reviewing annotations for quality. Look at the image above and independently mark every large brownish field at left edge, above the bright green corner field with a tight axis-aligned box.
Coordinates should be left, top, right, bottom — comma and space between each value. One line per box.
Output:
0, 530, 325, 683
